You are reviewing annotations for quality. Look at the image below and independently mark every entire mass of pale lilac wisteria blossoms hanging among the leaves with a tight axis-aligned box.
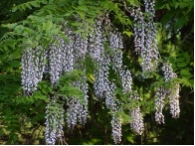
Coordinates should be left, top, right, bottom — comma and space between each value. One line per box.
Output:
21, 0, 180, 145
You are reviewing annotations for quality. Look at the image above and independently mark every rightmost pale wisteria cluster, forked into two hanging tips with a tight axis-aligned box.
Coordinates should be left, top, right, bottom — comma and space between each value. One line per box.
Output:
155, 63, 180, 124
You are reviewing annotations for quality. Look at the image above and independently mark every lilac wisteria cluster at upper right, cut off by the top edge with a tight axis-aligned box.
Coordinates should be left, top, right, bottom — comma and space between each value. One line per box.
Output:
131, 0, 159, 72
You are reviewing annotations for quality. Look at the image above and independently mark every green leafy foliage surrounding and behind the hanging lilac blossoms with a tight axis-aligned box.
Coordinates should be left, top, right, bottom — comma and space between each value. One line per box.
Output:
0, 0, 194, 144
